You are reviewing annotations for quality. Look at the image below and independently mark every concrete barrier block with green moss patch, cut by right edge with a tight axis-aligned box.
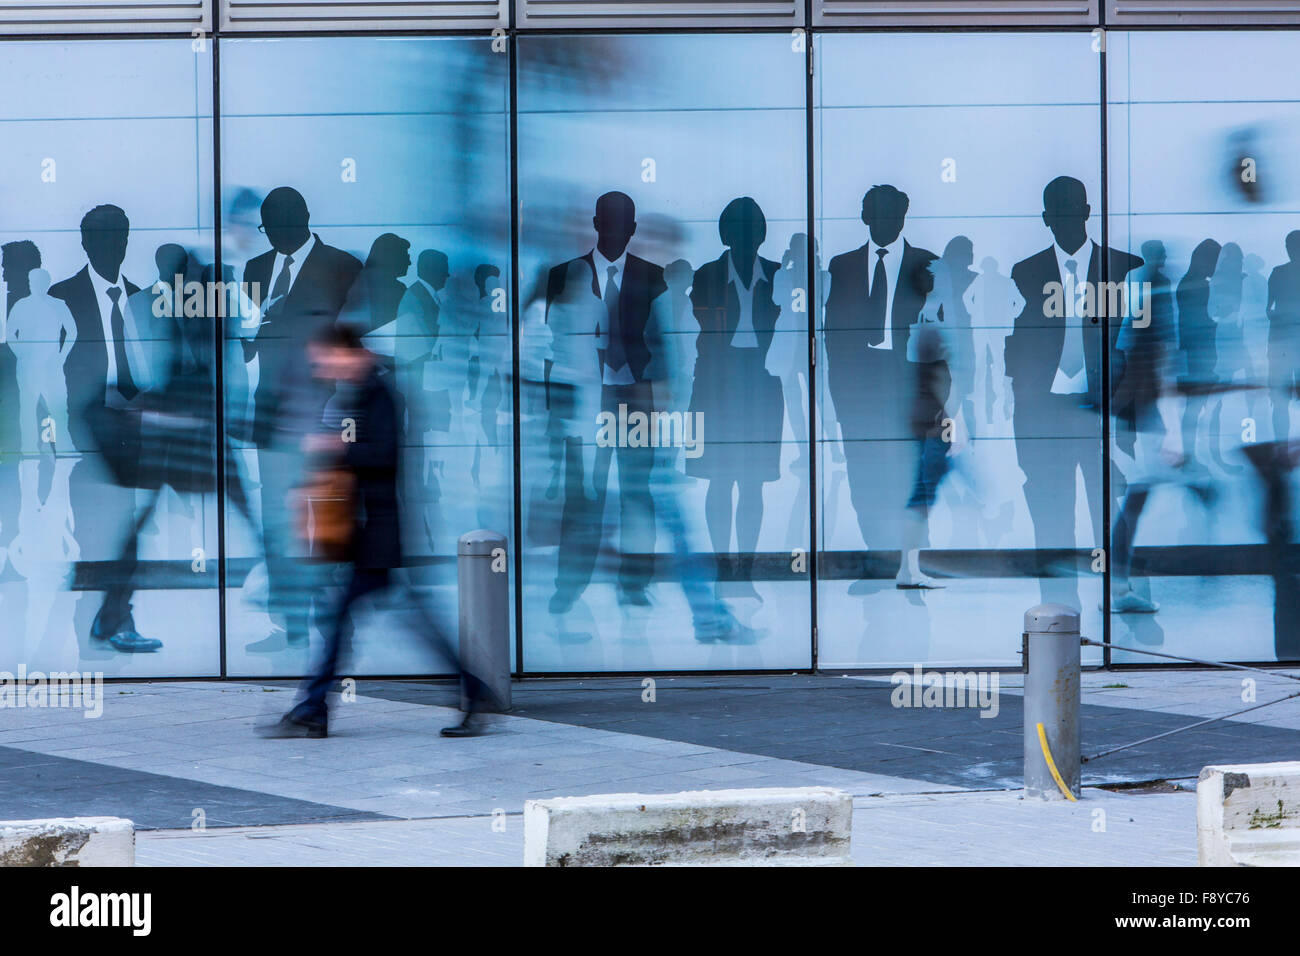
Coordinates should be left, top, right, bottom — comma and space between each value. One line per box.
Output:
1196, 761, 1300, 866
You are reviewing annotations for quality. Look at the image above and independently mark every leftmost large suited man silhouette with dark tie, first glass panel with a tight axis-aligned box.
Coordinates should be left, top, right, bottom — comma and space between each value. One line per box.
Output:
49, 204, 163, 653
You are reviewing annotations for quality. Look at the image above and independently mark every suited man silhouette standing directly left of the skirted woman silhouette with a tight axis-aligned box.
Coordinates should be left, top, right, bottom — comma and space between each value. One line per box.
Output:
546, 193, 668, 614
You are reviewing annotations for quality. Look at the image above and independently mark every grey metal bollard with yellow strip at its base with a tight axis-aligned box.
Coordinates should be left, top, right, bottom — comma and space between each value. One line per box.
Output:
1021, 604, 1082, 800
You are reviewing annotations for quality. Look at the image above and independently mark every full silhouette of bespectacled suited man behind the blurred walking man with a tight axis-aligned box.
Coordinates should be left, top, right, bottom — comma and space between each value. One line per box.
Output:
242, 186, 361, 652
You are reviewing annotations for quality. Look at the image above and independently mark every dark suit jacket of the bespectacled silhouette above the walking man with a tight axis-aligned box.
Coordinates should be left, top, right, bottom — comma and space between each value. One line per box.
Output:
243, 234, 361, 447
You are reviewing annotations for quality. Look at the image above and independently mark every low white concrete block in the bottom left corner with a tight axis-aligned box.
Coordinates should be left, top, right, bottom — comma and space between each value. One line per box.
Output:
0, 817, 135, 866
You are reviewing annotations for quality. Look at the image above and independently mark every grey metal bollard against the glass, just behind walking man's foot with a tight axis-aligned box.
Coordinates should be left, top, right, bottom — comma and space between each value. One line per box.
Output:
456, 531, 510, 710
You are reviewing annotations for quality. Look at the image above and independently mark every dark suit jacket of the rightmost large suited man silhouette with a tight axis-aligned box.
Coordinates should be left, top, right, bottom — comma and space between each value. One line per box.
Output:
1006, 241, 1141, 416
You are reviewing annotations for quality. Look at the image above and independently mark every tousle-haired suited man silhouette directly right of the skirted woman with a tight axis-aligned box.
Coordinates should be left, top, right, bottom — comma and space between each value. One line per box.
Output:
826, 186, 936, 564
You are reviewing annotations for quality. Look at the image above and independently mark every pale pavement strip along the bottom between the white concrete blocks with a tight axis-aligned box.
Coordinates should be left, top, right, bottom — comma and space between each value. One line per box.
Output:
137, 790, 1196, 866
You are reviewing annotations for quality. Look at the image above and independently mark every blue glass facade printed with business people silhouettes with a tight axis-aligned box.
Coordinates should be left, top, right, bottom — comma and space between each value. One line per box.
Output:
0, 30, 1300, 676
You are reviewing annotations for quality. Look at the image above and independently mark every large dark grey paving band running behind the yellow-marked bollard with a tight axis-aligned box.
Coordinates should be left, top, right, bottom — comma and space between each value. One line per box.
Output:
358, 675, 1300, 787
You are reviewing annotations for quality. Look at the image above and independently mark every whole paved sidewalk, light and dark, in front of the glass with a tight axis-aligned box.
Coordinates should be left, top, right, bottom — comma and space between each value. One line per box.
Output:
0, 671, 1279, 866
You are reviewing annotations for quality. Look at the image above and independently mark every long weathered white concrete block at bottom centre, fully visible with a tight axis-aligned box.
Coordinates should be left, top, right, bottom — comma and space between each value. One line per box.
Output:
524, 787, 853, 866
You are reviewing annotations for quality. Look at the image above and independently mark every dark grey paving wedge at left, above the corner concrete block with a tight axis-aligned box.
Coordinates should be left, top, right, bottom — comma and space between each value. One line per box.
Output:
0, 747, 393, 830
